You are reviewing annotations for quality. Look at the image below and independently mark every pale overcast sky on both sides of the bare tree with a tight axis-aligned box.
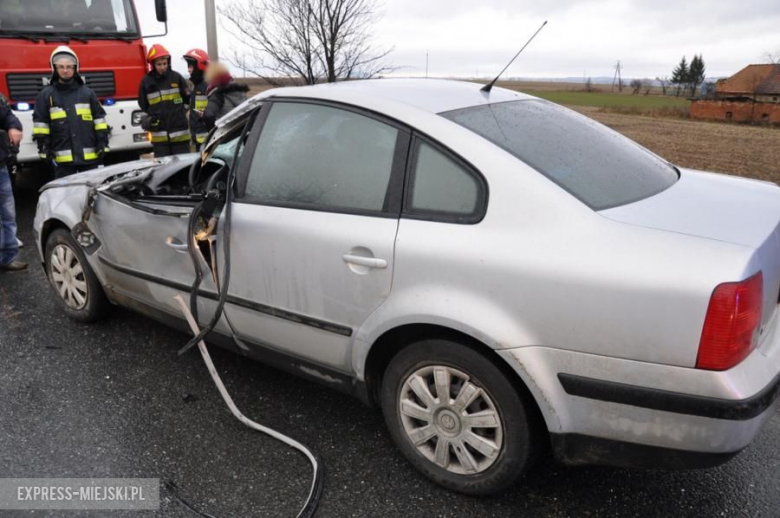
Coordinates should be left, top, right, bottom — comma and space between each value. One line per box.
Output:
136, 0, 780, 78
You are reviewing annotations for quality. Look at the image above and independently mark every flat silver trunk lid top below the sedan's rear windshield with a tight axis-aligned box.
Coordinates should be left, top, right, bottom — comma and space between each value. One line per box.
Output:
599, 169, 780, 248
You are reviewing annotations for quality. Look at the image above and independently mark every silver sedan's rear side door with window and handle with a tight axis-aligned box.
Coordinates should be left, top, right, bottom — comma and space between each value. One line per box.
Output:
225, 100, 410, 372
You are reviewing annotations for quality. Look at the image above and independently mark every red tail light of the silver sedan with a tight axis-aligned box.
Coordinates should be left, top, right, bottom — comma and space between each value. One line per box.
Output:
696, 272, 764, 371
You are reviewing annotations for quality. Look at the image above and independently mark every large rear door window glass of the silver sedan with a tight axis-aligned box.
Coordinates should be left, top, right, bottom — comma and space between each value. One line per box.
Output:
246, 102, 398, 213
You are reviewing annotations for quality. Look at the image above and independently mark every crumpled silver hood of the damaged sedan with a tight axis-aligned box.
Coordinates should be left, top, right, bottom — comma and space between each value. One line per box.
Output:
40, 153, 200, 192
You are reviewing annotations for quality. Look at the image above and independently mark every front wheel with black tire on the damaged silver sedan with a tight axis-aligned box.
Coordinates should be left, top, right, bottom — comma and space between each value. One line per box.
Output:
45, 228, 111, 322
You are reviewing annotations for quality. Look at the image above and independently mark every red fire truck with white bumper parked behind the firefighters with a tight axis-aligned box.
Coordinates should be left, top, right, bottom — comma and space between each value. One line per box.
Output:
0, 0, 167, 162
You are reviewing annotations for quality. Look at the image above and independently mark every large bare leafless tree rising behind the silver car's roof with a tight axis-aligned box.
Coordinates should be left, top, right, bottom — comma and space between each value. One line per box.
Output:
218, 0, 393, 85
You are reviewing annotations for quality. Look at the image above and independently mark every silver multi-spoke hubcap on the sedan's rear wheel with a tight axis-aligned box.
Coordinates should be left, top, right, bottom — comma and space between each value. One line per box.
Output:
399, 365, 503, 475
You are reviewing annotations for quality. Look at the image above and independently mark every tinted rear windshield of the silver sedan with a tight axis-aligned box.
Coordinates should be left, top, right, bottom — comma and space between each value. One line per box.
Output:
441, 100, 678, 210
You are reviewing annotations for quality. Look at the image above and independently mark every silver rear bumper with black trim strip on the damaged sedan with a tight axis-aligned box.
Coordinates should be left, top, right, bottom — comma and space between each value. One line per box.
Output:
499, 306, 780, 468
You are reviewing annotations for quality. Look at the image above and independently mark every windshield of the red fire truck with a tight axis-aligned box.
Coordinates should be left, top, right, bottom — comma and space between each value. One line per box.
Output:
0, 0, 138, 37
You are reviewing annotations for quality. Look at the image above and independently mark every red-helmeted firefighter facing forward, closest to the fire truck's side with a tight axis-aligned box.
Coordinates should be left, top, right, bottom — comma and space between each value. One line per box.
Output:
138, 44, 190, 157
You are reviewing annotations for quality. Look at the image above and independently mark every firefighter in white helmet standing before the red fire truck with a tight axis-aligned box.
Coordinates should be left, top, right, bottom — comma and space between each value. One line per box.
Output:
33, 45, 109, 178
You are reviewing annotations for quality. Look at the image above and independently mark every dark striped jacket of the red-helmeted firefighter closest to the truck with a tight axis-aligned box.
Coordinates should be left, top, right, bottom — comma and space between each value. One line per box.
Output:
138, 69, 190, 144
